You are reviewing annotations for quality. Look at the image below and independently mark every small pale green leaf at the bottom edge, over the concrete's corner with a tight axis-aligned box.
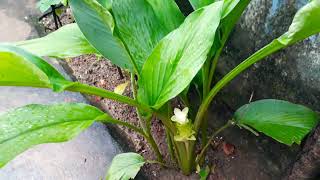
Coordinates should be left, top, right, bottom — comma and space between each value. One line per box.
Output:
106, 153, 145, 180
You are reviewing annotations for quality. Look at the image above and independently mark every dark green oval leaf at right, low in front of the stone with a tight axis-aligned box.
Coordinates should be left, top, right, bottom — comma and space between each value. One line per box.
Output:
234, 99, 319, 145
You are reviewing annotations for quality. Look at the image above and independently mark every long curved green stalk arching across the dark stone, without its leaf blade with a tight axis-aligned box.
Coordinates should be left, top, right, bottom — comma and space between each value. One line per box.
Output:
194, 40, 284, 133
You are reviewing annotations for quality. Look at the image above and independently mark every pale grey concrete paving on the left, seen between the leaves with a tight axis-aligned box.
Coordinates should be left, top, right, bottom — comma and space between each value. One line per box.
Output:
0, 0, 121, 180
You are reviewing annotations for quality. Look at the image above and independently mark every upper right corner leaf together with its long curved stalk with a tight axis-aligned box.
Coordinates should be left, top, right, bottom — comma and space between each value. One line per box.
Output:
200, 0, 320, 121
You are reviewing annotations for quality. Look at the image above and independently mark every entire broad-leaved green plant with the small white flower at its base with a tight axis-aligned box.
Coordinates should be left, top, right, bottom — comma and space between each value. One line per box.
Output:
0, 0, 320, 179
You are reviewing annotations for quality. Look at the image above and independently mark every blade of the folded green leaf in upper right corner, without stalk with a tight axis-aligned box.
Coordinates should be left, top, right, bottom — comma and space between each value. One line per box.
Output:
278, 0, 320, 46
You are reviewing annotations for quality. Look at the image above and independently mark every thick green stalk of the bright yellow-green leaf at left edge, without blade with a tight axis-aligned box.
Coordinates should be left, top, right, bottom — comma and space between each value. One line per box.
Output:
66, 83, 152, 112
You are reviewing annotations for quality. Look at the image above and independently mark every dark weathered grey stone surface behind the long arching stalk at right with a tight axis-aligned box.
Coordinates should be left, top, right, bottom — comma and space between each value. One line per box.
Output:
218, 0, 320, 110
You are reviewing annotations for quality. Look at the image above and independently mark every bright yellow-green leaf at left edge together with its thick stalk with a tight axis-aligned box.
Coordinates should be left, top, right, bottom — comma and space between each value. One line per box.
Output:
0, 44, 142, 107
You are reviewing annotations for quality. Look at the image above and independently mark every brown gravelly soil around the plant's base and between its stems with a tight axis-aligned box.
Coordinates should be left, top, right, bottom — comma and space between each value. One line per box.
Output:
39, 7, 318, 180
